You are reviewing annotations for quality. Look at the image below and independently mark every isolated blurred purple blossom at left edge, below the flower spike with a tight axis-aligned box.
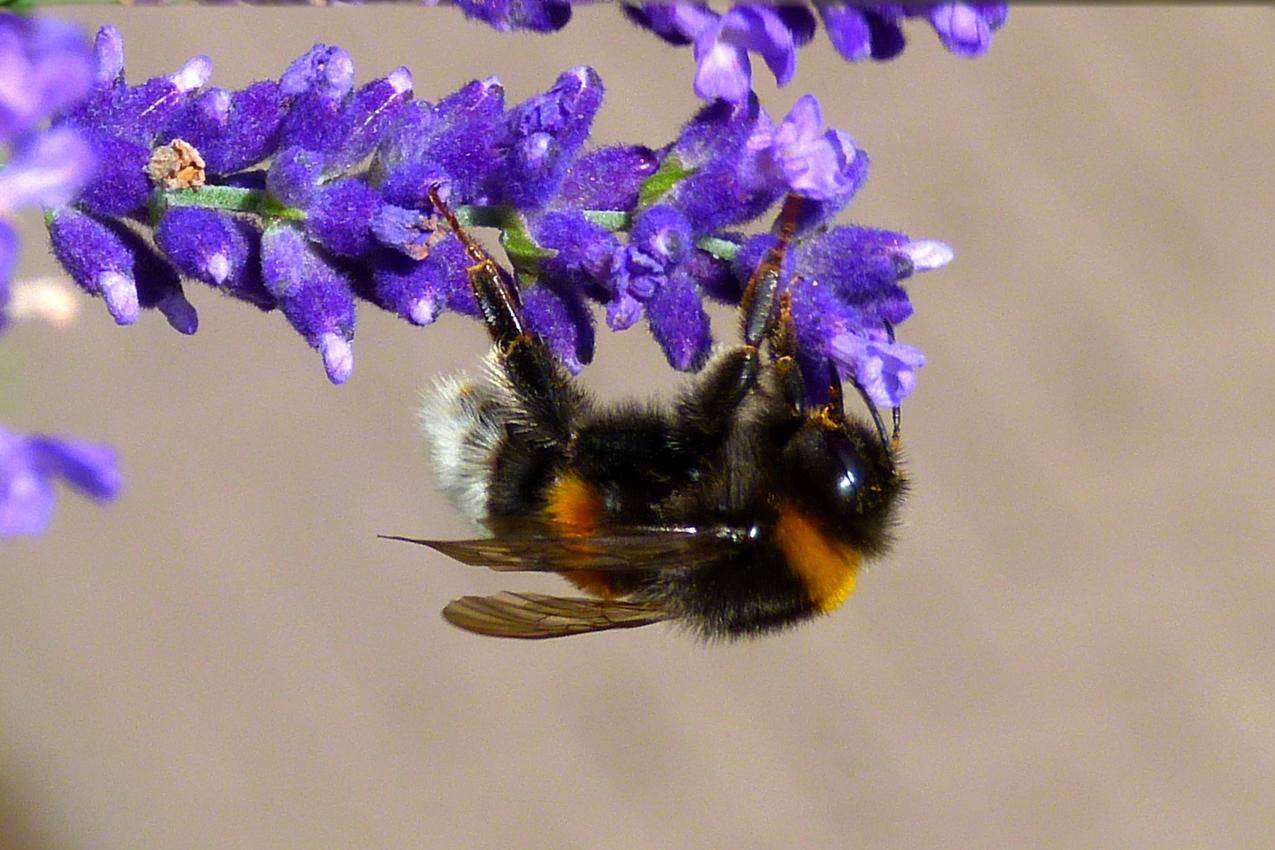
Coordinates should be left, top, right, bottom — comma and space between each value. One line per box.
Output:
0, 428, 122, 538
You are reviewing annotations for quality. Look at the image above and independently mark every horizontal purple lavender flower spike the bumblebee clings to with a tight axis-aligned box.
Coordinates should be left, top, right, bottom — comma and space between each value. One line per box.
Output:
47, 28, 950, 404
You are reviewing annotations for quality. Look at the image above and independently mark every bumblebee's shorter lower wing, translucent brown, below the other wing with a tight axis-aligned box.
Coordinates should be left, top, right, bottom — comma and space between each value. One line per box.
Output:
442, 591, 669, 640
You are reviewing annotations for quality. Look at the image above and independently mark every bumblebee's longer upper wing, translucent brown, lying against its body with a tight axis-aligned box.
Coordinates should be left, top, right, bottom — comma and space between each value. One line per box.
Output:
383, 526, 747, 572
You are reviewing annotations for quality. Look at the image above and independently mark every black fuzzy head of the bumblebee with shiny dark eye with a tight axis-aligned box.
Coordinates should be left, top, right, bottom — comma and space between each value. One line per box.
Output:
783, 408, 907, 554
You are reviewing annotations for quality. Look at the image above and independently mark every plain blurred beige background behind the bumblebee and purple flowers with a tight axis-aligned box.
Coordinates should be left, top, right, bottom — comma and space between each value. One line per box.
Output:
0, 8, 1275, 850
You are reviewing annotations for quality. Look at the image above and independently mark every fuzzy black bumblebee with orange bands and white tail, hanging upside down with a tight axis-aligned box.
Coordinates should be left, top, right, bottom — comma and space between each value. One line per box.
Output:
391, 189, 905, 640
